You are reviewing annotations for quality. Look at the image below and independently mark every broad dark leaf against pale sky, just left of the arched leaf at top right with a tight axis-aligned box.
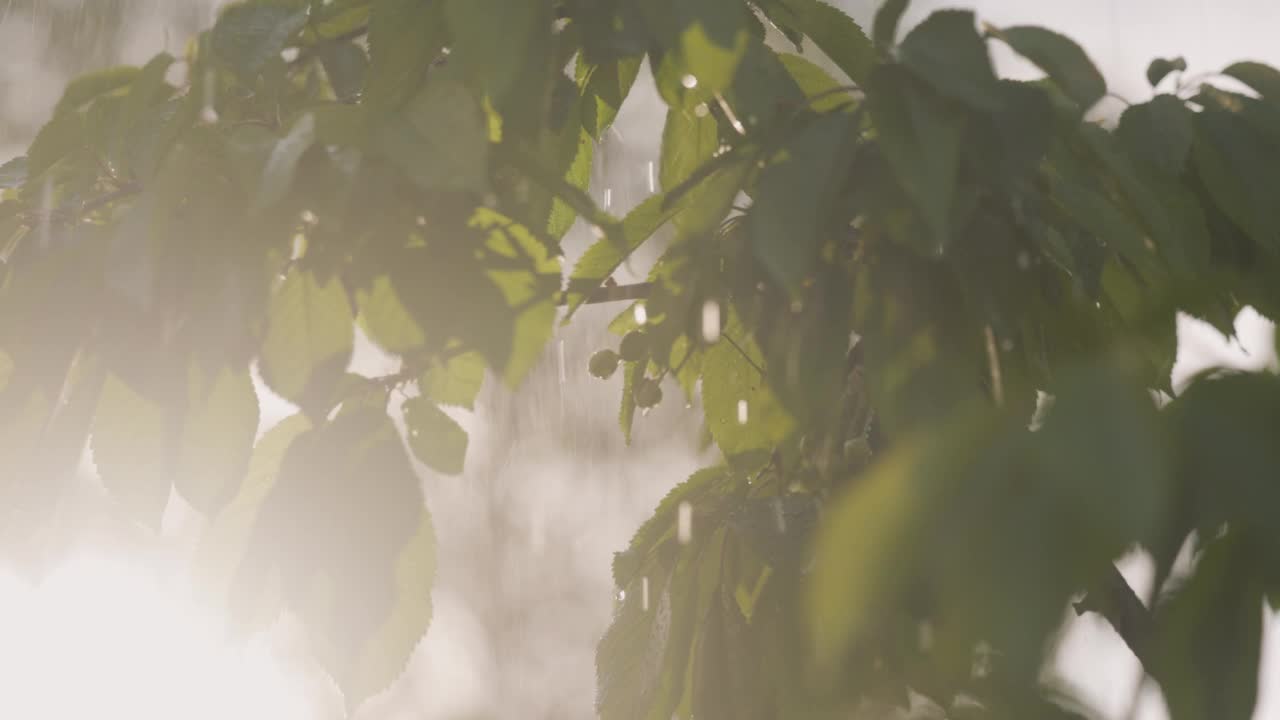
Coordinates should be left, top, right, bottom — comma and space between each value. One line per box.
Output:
897, 10, 1001, 110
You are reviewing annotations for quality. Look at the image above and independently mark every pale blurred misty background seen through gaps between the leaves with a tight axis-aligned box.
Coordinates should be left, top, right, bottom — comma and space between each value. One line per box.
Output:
0, 0, 1280, 720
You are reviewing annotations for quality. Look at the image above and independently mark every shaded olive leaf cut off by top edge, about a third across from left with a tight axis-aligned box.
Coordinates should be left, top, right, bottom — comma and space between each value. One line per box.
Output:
362, 0, 447, 118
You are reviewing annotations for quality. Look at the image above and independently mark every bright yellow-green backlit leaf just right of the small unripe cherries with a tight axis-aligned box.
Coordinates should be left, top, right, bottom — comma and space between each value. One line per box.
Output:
703, 320, 795, 457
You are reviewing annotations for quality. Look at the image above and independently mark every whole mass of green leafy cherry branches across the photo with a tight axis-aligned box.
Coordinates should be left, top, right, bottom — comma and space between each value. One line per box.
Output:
0, 0, 1280, 720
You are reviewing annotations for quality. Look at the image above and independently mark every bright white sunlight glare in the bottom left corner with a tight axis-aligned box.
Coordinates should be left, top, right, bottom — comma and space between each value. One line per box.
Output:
0, 555, 316, 720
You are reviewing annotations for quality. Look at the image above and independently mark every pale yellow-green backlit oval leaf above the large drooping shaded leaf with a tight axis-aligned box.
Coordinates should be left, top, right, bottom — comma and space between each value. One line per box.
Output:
259, 268, 355, 411
